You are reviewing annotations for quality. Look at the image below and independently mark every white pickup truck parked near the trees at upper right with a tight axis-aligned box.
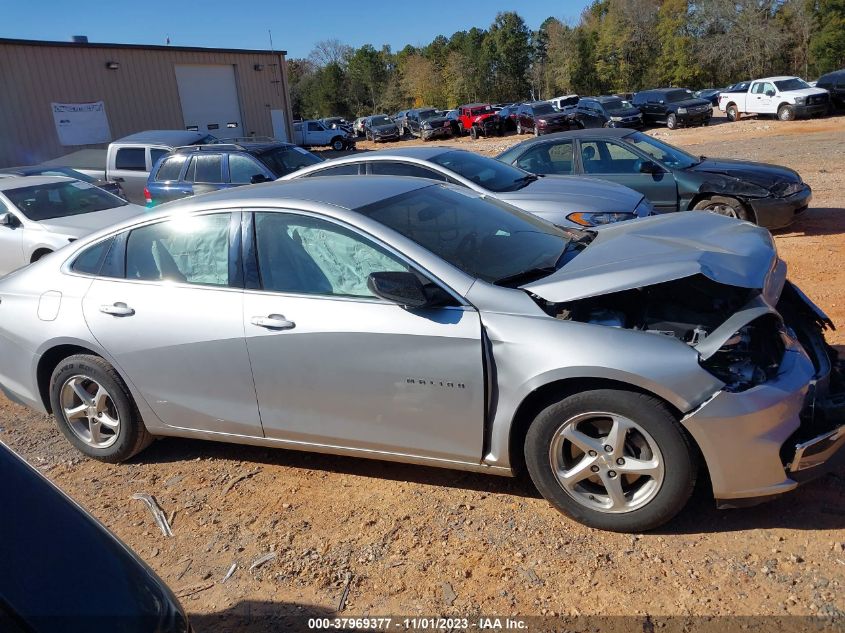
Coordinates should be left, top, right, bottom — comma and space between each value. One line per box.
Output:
719, 77, 830, 121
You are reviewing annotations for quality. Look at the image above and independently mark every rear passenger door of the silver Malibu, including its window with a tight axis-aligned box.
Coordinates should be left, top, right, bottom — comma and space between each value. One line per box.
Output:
82, 213, 262, 437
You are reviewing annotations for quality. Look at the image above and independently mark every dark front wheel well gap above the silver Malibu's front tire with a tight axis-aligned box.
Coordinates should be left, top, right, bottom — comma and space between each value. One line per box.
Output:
508, 378, 681, 473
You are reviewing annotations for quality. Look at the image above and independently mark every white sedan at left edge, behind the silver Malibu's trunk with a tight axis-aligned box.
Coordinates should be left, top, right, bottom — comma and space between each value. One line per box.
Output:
0, 176, 144, 275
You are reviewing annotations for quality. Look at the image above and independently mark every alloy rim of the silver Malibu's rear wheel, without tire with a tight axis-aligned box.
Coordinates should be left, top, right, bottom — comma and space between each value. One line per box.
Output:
61, 375, 120, 448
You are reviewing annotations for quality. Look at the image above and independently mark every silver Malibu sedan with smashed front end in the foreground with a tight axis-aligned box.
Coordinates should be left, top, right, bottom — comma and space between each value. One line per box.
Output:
0, 177, 845, 531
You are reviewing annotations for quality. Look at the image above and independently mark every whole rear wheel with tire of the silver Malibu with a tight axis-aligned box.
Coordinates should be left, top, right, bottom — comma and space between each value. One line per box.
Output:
50, 354, 153, 464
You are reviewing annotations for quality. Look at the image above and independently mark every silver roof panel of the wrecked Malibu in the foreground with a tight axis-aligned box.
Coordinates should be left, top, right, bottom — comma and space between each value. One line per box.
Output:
161, 176, 435, 211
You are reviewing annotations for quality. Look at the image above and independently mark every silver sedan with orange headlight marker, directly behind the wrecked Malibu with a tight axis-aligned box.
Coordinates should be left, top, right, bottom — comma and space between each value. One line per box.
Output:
280, 147, 654, 227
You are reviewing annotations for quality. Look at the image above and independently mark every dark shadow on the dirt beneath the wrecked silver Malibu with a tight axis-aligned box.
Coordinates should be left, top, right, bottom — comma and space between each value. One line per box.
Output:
133, 430, 845, 535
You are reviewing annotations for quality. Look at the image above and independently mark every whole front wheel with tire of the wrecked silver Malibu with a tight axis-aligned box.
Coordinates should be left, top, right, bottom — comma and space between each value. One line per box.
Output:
525, 389, 697, 532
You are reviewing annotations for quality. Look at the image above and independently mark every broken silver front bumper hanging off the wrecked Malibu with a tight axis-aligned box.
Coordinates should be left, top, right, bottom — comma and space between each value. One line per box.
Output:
681, 298, 845, 508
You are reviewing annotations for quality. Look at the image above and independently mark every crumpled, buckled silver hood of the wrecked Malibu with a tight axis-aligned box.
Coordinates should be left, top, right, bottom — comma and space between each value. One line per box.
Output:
522, 211, 777, 302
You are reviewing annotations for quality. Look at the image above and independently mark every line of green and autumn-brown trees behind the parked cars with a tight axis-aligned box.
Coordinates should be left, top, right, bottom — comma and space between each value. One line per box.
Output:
287, 0, 845, 118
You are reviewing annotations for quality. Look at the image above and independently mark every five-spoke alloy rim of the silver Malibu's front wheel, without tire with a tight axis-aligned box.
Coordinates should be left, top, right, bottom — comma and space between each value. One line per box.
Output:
549, 412, 664, 514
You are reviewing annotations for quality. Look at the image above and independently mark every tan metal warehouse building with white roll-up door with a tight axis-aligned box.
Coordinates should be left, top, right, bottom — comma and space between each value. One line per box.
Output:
0, 38, 292, 167
